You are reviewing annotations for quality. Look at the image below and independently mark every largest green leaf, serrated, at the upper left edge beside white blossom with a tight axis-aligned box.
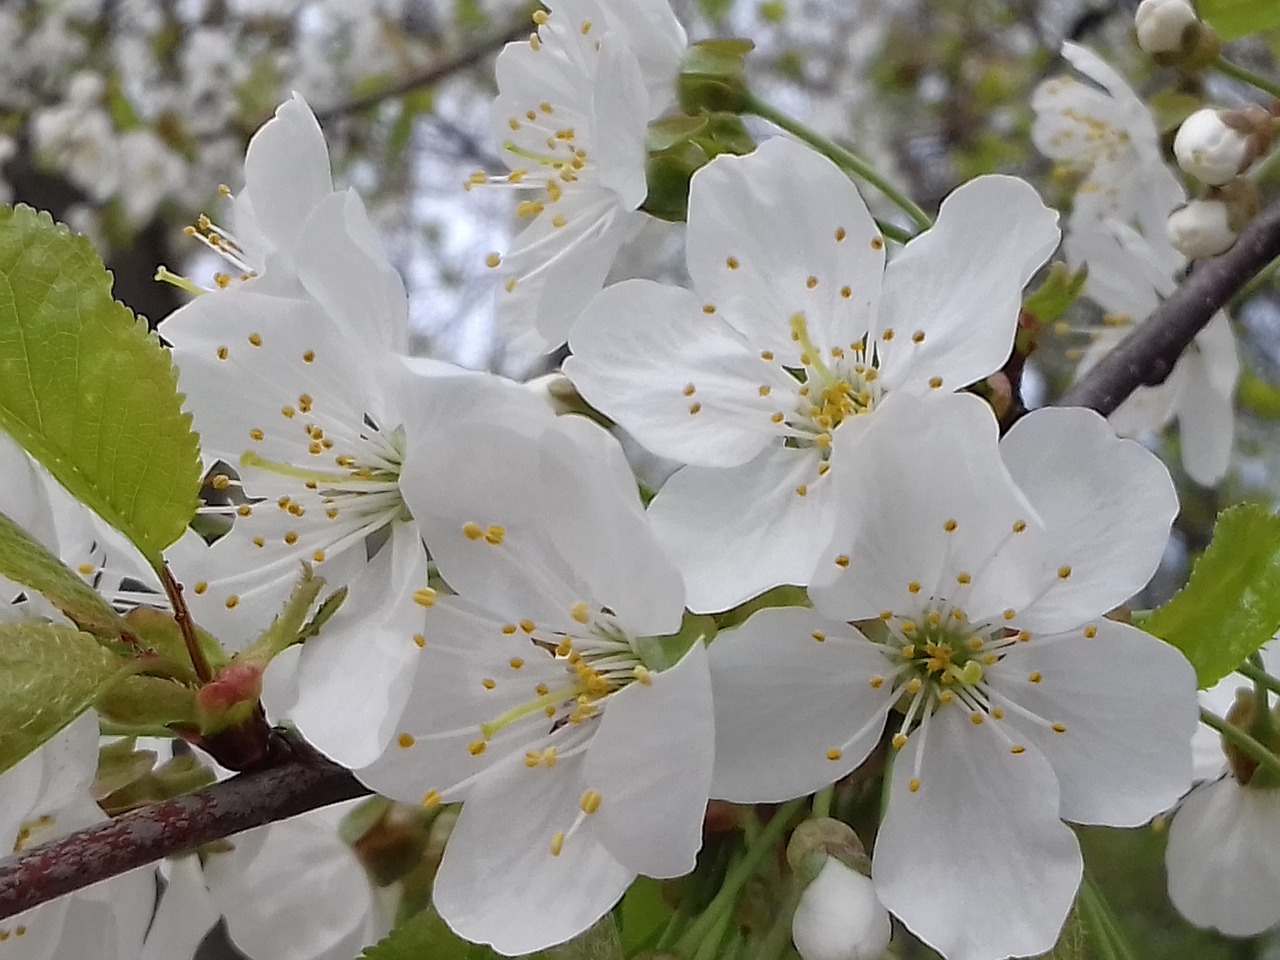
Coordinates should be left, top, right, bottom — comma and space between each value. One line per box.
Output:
0, 200, 200, 566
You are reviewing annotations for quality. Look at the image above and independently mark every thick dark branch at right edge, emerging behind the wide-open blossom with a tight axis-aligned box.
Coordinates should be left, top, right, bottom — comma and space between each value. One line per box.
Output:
1059, 201, 1280, 416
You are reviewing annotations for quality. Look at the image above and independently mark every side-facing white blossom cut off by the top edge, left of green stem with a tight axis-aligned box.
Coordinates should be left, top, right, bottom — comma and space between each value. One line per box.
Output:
467, 0, 686, 351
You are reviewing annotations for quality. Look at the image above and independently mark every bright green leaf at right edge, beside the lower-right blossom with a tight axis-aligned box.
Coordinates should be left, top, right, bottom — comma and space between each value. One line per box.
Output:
1143, 503, 1280, 689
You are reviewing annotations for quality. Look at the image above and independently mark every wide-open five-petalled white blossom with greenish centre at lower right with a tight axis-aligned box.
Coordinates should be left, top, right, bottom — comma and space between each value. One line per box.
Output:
709, 394, 1197, 960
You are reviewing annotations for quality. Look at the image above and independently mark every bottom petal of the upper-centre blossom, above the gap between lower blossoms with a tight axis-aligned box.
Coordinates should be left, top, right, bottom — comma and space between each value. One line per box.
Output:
649, 444, 836, 612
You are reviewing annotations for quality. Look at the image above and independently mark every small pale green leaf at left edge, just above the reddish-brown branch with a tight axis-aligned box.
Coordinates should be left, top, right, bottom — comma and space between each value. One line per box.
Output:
0, 621, 131, 773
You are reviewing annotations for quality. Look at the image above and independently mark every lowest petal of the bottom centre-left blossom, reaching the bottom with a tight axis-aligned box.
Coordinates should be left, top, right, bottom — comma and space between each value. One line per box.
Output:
434, 754, 635, 956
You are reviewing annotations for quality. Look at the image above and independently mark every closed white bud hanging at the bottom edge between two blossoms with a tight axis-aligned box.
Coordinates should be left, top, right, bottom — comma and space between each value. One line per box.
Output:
791, 856, 892, 960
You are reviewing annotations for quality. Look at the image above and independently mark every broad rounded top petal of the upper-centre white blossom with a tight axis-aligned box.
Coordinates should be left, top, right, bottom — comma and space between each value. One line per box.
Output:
687, 137, 884, 366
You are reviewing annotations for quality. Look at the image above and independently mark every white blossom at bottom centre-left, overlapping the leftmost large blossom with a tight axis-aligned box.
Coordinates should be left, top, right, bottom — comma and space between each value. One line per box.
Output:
357, 416, 713, 955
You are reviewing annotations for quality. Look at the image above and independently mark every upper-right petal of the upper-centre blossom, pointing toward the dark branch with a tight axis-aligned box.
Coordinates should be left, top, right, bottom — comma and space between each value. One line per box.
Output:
876, 177, 1059, 394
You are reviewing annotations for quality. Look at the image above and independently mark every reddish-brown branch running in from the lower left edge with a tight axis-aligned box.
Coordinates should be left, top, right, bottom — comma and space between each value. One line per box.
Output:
0, 733, 369, 920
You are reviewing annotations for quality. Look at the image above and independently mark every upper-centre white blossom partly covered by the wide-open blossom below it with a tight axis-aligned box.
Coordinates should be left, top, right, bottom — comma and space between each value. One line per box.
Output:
564, 138, 1059, 611
